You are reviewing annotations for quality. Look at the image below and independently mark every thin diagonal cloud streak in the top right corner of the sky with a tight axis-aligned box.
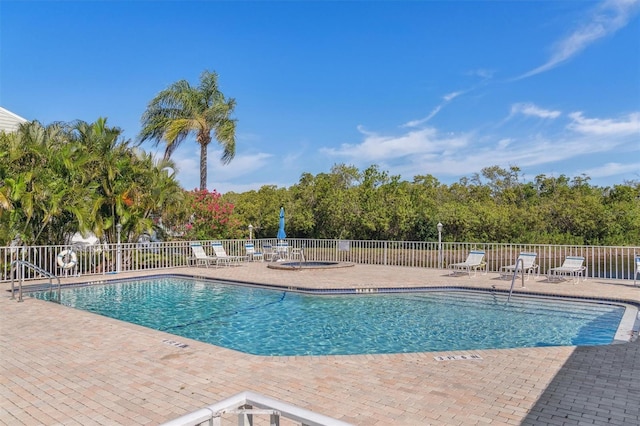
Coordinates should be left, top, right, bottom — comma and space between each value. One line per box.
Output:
516, 0, 640, 80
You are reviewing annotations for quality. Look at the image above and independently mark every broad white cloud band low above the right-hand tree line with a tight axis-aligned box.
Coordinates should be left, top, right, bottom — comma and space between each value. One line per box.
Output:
321, 104, 640, 179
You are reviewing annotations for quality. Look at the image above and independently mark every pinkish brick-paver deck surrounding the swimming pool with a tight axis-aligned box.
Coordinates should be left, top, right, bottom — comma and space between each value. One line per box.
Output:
0, 262, 640, 425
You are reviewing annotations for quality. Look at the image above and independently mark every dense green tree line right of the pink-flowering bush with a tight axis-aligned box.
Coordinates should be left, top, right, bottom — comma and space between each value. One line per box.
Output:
223, 164, 640, 245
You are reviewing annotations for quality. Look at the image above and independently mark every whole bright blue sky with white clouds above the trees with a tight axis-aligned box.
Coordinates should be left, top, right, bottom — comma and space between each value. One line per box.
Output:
0, 0, 640, 192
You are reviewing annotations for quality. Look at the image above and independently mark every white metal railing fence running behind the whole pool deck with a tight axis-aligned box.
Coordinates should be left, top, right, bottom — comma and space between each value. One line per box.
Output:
0, 238, 640, 281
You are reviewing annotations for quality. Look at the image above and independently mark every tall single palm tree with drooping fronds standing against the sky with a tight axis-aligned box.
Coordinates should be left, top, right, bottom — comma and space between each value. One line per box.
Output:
139, 71, 236, 190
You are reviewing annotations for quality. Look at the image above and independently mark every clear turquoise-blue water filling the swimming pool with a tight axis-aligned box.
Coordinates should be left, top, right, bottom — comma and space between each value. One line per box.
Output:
34, 277, 624, 355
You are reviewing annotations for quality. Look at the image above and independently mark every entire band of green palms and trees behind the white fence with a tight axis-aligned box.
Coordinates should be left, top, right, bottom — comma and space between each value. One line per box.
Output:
0, 119, 640, 245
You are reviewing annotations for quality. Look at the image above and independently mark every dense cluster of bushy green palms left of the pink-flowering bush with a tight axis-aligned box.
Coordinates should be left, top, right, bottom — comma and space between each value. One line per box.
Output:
0, 119, 188, 245
